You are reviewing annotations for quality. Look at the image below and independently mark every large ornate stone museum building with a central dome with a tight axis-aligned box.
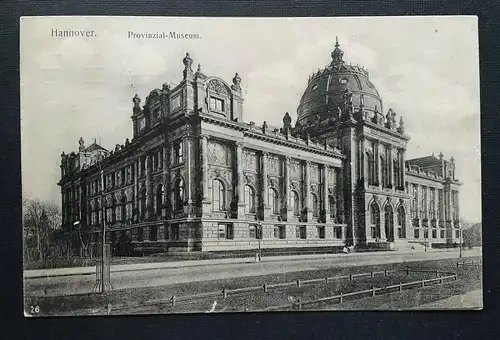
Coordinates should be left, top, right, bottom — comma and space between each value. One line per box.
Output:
59, 38, 461, 252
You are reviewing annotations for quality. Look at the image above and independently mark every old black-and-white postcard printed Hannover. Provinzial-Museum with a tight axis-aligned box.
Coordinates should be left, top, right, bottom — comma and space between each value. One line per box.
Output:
20, 16, 482, 317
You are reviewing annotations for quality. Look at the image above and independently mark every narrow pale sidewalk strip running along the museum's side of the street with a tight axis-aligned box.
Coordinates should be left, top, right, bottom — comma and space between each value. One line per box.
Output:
23, 249, 481, 279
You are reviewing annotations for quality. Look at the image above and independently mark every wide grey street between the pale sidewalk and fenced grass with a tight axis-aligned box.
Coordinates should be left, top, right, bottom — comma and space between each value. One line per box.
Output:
25, 249, 481, 295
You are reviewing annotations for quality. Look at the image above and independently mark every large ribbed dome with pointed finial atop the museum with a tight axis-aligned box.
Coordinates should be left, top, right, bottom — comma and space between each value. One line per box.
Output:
297, 40, 383, 126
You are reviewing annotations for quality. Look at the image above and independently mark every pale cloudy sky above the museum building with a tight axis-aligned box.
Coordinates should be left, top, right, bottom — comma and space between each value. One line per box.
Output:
20, 17, 481, 222
